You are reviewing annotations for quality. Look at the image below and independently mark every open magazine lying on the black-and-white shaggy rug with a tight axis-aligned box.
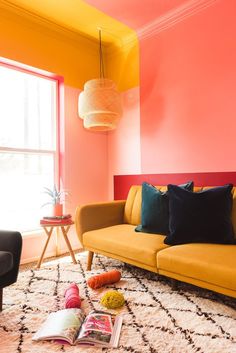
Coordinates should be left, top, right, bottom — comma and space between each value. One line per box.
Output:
33, 308, 122, 348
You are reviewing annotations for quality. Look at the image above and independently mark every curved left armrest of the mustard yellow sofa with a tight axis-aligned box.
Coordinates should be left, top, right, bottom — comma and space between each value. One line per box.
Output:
75, 200, 126, 245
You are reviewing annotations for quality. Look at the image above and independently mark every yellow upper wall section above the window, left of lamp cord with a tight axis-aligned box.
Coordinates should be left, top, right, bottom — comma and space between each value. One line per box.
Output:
0, 6, 98, 88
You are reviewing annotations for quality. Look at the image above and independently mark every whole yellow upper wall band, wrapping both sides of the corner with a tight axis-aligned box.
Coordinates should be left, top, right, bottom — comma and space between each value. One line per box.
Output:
0, 3, 139, 91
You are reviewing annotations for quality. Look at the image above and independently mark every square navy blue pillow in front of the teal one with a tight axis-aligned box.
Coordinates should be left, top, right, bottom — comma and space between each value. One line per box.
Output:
164, 184, 235, 245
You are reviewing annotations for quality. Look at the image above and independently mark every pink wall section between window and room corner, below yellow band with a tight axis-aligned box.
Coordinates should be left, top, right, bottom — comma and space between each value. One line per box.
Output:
61, 86, 108, 213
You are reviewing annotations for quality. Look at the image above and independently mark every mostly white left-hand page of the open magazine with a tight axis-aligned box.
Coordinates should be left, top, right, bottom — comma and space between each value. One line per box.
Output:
33, 308, 84, 344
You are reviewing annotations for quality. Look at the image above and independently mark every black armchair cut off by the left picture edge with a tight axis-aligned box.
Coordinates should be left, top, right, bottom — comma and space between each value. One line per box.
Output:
0, 230, 22, 311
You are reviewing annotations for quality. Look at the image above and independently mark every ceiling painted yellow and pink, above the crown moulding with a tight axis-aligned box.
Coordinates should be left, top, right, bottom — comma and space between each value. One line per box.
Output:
0, 0, 188, 46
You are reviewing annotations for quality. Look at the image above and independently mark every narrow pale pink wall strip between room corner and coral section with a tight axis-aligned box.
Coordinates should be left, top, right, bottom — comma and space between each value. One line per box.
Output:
108, 87, 141, 199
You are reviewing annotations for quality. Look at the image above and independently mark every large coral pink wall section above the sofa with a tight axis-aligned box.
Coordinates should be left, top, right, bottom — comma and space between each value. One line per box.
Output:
139, 0, 236, 173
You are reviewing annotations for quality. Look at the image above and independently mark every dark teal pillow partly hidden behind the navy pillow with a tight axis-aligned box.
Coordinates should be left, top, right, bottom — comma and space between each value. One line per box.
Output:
135, 181, 193, 235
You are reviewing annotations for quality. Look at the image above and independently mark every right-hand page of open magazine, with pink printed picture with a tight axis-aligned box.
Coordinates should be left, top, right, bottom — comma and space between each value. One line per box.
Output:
76, 311, 122, 347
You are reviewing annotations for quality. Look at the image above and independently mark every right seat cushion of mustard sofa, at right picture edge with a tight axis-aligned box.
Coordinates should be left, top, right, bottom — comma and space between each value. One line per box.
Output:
157, 244, 236, 290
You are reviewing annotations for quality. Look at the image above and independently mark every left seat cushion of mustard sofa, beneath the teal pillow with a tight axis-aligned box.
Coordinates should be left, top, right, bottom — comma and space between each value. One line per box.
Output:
83, 224, 168, 267
